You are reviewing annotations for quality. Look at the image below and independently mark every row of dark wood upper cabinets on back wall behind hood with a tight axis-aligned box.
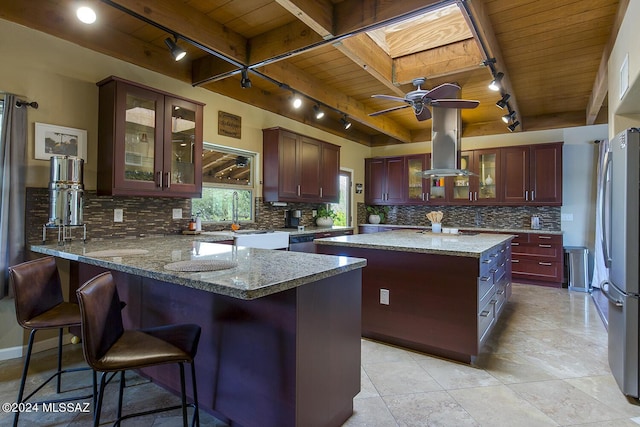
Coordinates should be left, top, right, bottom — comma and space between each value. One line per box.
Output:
365, 142, 562, 206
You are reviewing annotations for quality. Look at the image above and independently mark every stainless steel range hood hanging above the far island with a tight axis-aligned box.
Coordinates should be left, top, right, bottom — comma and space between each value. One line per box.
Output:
422, 107, 473, 178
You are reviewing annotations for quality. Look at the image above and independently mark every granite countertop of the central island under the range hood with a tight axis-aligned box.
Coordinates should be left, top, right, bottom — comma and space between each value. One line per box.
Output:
314, 230, 513, 258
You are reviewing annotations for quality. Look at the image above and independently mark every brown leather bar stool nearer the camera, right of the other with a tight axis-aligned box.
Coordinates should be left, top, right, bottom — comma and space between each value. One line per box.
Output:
76, 272, 200, 427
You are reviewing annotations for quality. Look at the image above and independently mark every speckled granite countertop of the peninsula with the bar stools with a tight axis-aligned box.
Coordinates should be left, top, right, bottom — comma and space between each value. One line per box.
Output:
31, 235, 366, 300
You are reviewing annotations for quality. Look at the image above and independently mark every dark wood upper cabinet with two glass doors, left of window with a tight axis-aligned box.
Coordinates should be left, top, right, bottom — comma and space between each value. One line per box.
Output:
97, 77, 204, 198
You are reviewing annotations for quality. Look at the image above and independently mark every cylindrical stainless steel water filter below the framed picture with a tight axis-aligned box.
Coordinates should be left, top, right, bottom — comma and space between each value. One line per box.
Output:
48, 156, 84, 226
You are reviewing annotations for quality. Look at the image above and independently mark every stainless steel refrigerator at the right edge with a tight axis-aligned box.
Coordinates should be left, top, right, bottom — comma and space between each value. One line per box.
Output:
600, 128, 640, 398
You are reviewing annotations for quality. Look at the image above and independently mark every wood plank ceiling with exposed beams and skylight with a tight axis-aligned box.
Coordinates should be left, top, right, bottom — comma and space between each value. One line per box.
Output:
0, 0, 628, 146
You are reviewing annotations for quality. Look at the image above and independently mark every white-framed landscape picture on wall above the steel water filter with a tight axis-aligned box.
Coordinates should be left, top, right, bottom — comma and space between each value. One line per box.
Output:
34, 123, 87, 163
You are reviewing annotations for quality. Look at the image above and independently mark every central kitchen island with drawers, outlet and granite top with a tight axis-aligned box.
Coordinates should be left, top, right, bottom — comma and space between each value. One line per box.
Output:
314, 230, 513, 363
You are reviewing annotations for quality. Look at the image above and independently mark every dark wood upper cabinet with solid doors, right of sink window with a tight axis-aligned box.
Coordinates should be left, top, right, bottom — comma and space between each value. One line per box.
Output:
262, 128, 340, 203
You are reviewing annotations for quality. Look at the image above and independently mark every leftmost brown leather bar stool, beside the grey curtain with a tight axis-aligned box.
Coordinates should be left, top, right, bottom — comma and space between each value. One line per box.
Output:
9, 256, 95, 427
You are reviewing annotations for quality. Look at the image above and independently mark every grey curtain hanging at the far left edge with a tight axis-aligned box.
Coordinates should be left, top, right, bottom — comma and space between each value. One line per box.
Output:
0, 95, 27, 298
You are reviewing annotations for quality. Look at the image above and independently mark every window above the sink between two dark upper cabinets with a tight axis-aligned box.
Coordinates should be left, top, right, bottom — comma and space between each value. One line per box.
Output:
191, 142, 256, 223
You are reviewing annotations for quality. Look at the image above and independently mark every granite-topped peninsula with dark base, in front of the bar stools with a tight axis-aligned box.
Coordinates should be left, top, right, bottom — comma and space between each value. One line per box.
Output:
31, 236, 366, 427
